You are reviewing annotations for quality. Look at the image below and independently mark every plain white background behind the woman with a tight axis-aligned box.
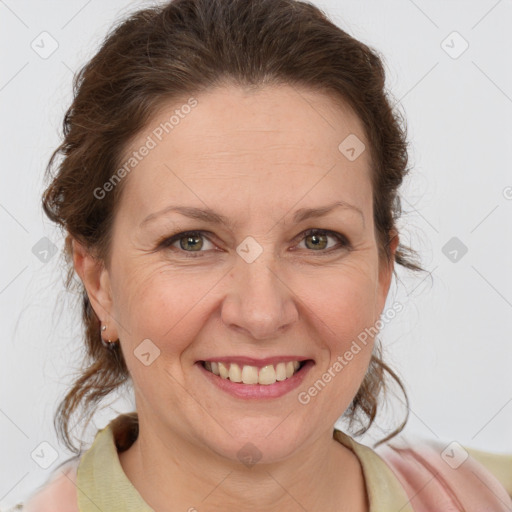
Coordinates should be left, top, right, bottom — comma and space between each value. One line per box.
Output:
0, 0, 512, 507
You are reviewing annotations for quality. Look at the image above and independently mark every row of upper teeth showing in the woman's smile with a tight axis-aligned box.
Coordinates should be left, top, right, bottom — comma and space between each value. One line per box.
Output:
204, 361, 300, 385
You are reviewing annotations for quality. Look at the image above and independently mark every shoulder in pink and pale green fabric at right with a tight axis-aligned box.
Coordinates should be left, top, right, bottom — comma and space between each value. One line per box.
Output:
375, 433, 512, 511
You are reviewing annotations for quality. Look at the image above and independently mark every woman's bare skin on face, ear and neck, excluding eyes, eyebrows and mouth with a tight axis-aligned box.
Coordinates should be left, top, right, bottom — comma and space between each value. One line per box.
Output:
74, 85, 398, 512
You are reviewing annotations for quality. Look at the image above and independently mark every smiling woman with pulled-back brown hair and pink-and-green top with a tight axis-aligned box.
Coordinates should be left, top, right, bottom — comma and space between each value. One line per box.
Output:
9, 0, 512, 512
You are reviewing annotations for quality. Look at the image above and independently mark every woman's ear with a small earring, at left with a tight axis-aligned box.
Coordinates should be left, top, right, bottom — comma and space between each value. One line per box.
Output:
72, 239, 119, 340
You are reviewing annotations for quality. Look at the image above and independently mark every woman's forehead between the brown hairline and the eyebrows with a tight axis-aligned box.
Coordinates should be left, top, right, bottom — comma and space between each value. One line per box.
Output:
116, 86, 371, 219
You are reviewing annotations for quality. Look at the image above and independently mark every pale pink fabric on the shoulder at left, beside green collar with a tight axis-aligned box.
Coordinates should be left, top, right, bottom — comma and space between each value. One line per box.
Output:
14, 456, 80, 512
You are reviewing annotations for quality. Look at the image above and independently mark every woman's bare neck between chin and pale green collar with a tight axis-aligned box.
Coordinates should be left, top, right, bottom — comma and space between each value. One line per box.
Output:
119, 418, 369, 512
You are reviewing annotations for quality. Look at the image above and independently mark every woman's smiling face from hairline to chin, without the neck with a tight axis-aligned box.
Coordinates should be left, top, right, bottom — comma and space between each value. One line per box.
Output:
83, 86, 396, 462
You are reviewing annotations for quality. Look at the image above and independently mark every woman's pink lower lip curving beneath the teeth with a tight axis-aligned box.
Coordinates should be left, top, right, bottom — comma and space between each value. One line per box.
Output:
196, 360, 315, 400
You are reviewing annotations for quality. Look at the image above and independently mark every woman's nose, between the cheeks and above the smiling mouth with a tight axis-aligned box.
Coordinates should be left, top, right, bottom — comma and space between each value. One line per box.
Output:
221, 256, 299, 340
